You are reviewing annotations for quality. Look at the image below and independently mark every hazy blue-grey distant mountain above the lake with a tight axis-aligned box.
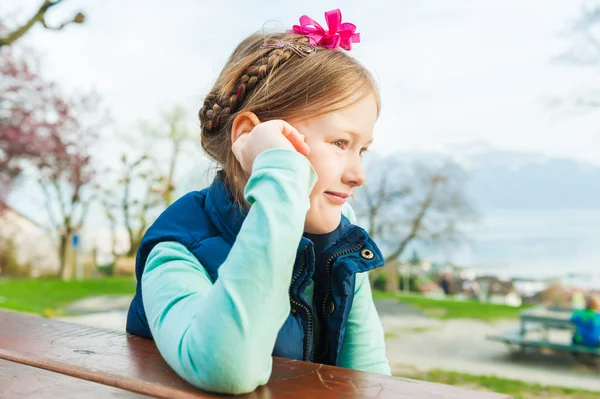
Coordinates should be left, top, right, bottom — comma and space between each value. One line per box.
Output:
390, 147, 600, 210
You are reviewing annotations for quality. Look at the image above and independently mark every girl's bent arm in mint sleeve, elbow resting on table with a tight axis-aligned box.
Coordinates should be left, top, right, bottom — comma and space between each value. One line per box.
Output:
142, 149, 317, 394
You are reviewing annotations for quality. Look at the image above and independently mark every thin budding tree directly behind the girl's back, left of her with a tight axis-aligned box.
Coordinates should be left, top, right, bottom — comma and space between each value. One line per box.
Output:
99, 105, 196, 258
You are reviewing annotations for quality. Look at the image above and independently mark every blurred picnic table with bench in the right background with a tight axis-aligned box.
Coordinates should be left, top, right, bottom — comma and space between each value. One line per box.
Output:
486, 307, 600, 364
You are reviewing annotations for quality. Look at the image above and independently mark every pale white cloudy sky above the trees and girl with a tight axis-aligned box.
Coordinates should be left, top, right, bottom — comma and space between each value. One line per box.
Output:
0, 0, 600, 164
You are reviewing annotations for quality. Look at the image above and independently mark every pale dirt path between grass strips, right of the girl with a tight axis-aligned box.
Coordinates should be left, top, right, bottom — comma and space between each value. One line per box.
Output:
378, 303, 600, 391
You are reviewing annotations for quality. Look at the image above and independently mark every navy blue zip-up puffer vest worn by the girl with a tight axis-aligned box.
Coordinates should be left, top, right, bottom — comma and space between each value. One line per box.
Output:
126, 176, 383, 365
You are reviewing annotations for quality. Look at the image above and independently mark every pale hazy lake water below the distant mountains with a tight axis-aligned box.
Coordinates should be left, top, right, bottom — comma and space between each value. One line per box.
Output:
423, 209, 600, 288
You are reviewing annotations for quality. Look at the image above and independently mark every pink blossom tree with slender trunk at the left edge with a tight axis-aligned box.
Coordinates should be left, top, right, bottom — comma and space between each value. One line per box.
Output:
0, 47, 104, 276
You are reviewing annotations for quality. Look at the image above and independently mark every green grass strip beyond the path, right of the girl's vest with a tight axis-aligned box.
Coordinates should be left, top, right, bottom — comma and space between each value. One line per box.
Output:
373, 291, 526, 321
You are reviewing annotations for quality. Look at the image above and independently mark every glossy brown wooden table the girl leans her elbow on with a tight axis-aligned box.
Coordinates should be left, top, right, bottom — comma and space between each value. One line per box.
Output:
0, 311, 509, 399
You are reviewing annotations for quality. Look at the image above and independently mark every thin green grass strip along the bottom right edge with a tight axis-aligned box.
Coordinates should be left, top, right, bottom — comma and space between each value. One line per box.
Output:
394, 370, 600, 399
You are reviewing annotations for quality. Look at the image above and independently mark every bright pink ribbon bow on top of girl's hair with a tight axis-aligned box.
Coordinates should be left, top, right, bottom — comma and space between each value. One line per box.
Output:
292, 9, 360, 51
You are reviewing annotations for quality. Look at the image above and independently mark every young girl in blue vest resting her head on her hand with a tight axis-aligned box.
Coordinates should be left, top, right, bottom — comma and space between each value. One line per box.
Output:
127, 10, 390, 394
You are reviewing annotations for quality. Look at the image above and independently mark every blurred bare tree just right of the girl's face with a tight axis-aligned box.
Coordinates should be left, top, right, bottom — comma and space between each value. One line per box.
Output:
356, 158, 475, 291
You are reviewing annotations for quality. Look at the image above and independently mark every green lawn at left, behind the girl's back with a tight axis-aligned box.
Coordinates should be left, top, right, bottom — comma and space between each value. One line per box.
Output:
0, 277, 135, 316
